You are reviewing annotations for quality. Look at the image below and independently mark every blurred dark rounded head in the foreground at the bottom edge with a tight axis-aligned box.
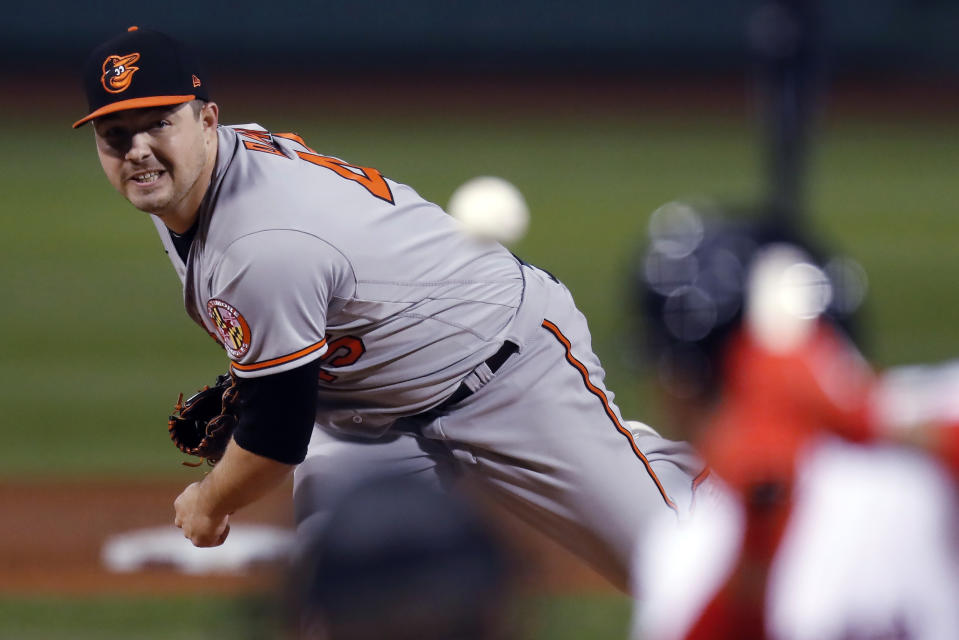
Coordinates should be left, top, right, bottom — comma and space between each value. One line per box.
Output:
289, 476, 513, 640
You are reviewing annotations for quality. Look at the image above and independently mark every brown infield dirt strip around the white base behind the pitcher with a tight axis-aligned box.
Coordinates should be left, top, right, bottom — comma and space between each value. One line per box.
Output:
0, 478, 612, 595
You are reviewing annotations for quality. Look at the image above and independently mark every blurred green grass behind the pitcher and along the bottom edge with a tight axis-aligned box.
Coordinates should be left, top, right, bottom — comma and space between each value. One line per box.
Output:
0, 87, 959, 639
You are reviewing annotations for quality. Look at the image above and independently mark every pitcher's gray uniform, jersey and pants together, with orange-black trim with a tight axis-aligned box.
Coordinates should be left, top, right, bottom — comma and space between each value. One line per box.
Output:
155, 124, 703, 587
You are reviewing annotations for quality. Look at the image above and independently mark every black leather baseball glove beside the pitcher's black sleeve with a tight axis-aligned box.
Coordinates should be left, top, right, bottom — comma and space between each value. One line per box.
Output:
168, 374, 237, 467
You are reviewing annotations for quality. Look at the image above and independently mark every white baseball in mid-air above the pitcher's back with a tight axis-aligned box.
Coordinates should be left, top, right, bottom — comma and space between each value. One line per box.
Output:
446, 176, 529, 245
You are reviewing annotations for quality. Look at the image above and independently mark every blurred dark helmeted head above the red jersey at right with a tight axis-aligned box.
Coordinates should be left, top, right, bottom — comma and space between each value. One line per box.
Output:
630, 201, 866, 436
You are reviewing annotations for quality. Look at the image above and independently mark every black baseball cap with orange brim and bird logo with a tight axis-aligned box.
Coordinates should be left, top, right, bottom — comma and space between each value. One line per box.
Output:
73, 27, 210, 129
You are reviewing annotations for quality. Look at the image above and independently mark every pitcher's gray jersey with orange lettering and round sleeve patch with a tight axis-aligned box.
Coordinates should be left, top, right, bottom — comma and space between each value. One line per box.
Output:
154, 124, 522, 436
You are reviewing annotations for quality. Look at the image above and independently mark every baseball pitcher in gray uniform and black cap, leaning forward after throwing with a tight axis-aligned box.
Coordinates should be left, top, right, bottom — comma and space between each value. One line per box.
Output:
74, 27, 702, 588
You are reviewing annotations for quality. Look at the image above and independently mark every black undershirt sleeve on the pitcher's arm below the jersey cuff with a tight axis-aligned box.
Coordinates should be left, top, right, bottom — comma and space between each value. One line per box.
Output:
233, 358, 320, 464
